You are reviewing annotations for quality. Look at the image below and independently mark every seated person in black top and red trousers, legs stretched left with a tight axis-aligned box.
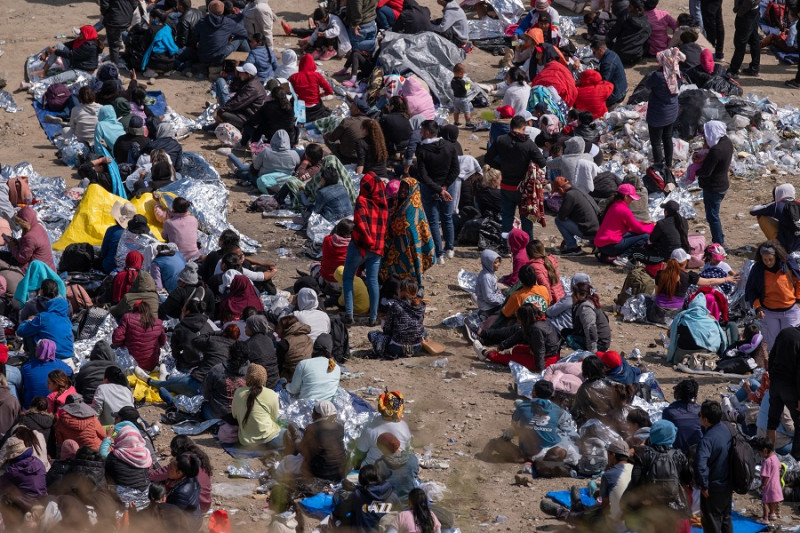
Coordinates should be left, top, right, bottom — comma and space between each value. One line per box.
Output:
472, 303, 561, 372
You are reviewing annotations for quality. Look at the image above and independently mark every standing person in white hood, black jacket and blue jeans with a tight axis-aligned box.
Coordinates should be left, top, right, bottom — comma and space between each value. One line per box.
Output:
697, 120, 733, 247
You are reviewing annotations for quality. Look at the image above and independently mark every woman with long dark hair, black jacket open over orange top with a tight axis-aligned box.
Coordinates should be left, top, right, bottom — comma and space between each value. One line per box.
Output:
744, 240, 800, 350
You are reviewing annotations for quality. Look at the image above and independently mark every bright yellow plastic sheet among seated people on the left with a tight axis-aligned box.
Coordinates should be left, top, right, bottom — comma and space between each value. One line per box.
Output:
53, 183, 164, 251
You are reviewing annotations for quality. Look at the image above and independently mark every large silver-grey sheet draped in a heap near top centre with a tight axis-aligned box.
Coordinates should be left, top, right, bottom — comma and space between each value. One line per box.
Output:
379, 32, 485, 106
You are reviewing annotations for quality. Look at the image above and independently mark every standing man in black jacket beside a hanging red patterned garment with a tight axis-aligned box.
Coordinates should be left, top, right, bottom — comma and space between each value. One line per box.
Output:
485, 115, 547, 238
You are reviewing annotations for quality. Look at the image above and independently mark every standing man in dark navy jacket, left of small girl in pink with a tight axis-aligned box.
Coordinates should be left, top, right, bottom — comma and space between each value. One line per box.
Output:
694, 395, 732, 533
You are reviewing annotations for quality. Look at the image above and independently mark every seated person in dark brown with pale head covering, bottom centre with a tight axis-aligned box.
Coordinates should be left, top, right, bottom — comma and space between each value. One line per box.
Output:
276, 401, 347, 482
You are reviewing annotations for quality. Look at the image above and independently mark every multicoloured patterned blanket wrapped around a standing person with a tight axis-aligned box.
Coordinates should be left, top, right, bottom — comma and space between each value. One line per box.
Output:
380, 178, 436, 286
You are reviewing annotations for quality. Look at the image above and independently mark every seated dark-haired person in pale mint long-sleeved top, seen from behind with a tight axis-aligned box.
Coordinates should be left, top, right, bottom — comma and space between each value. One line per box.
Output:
286, 333, 342, 401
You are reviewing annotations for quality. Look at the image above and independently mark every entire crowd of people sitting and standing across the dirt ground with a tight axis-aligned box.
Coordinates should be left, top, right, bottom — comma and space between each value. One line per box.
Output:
0, 0, 800, 533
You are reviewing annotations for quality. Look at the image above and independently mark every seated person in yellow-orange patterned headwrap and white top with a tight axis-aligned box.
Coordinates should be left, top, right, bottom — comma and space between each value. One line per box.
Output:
354, 388, 411, 470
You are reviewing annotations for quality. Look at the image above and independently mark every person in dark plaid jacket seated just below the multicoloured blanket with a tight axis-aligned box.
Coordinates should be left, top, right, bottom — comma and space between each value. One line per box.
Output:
367, 279, 425, 359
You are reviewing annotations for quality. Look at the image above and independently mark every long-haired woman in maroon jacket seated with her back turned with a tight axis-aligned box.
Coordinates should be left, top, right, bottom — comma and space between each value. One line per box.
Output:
111, 301, 167, 372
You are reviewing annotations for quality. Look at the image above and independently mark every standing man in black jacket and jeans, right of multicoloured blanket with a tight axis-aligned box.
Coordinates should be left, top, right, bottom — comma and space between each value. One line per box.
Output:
417, 120, 460, 265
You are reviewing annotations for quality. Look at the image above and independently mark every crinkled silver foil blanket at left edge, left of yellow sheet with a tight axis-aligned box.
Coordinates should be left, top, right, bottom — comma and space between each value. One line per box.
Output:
0, 162, 75, 243
